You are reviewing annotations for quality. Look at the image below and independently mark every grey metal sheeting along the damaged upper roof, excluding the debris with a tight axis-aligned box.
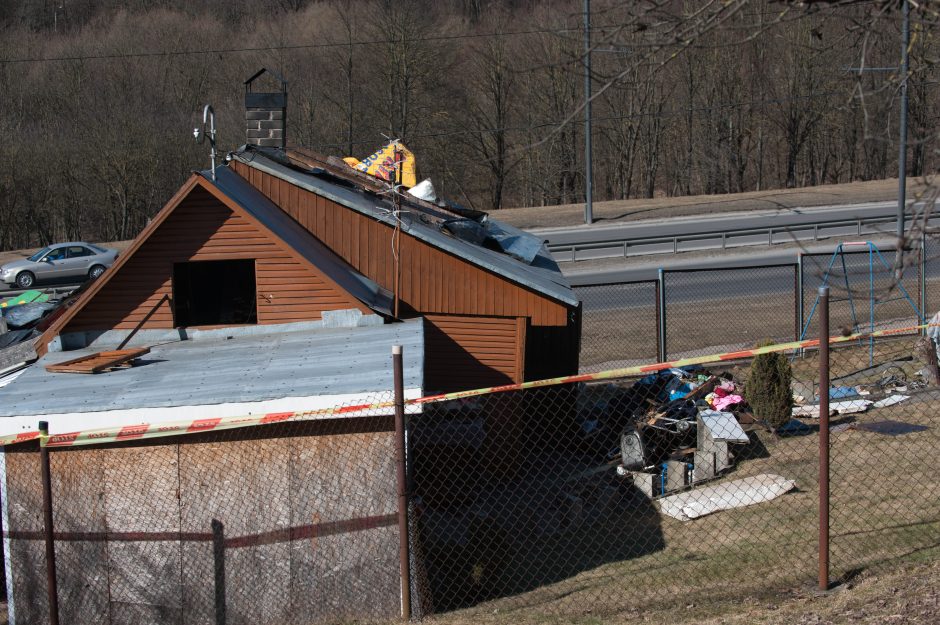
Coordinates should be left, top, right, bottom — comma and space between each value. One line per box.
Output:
229, 146, 578, 306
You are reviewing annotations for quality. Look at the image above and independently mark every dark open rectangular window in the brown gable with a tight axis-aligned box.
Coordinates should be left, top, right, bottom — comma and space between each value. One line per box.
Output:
173, 260, 258, 328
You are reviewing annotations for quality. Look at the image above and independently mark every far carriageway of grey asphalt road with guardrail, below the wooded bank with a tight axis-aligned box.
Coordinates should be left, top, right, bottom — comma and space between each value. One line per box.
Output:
530, 202, 940, 262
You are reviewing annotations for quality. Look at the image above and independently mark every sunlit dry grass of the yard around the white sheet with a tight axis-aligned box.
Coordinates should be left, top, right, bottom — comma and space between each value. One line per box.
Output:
410, 337, 940, 625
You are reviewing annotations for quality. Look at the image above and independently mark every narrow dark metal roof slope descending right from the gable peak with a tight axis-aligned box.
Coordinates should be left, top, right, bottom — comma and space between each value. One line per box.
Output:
207, 167, 392, 316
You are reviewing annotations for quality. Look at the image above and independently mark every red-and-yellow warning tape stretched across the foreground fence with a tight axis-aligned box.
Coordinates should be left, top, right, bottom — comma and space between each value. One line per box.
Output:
0, 324, 928, 447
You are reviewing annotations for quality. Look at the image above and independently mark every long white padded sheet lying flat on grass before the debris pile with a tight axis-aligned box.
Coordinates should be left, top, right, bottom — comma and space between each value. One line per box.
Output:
659, 473, 796, 521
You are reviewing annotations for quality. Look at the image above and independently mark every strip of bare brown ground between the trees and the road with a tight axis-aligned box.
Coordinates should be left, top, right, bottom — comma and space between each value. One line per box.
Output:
493, 179, 926, 228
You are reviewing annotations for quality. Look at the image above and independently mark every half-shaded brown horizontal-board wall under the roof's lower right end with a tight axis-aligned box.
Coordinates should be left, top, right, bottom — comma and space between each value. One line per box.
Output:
424, 315, 526, 392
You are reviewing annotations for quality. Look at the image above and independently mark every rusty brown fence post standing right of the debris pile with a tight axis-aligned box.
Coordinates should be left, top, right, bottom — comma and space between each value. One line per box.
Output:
819, 286, 829, 590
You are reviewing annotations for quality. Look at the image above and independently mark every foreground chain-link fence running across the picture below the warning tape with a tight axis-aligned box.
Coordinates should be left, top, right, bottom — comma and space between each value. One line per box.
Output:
3, 316, 940, 625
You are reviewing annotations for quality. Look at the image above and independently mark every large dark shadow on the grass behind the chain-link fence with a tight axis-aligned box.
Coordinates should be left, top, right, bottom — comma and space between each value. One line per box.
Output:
412, 400, 665, 613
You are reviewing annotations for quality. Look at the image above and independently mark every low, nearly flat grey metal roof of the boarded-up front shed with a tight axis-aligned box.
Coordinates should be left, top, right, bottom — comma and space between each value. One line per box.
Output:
0, 320, 424, 434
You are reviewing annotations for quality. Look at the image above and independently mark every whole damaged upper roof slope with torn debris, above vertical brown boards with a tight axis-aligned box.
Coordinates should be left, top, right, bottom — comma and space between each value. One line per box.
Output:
229, 146, 578, 306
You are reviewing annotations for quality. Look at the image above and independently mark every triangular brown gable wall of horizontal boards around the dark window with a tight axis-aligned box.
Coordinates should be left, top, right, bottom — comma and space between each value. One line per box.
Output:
63, 187, 370, 332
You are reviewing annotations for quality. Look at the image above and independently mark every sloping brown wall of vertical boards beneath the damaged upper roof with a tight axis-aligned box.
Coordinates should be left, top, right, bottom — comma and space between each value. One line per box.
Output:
231, 161, 568, 326
